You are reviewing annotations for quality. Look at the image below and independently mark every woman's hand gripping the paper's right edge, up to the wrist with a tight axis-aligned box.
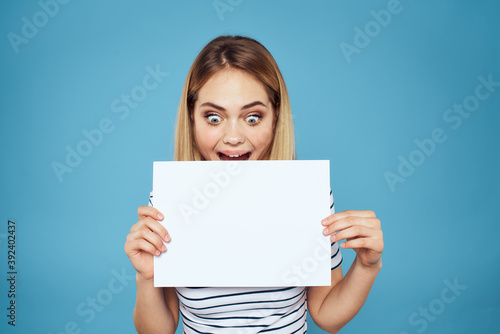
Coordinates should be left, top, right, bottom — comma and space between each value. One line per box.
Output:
321, 210, 384, 268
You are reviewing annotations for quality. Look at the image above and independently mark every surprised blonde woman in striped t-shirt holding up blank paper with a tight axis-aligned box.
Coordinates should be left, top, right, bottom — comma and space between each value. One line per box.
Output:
125, 36, 383, 333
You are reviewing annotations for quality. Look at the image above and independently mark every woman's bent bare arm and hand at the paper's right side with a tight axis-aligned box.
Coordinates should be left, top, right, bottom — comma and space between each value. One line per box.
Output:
307, 211, 384, 333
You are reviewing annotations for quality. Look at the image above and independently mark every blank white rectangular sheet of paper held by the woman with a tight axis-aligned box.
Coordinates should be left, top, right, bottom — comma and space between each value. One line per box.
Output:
153, 160, 331, 287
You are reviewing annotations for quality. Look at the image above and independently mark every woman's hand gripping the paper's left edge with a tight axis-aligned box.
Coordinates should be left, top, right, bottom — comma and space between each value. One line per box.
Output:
124, 206, 170, 280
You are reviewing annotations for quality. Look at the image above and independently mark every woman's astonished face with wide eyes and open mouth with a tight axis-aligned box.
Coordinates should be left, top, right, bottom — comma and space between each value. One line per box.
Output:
192, 69, 275, 160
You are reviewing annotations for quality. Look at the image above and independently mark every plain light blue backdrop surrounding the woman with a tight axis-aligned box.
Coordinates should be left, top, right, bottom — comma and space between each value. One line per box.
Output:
0, 0, 500, 334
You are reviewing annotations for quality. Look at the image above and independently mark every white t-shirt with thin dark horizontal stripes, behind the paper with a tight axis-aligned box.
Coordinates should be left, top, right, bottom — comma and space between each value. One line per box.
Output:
149, 190, 342, 334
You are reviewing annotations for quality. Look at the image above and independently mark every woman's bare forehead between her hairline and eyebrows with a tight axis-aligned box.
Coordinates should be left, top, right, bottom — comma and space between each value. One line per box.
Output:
198, 69, 269, 103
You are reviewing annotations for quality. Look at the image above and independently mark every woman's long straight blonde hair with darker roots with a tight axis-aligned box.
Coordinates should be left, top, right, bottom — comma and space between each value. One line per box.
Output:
174, 36, 297, 161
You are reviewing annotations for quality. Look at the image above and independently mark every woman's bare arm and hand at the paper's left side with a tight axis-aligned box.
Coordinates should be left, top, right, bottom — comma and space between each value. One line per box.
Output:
125, 206, 179, 334
